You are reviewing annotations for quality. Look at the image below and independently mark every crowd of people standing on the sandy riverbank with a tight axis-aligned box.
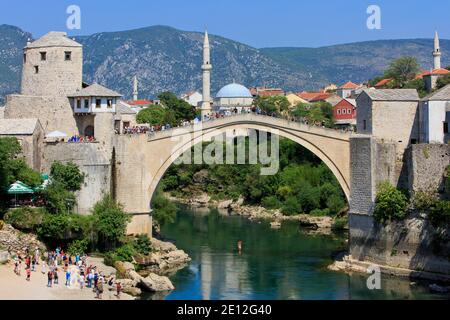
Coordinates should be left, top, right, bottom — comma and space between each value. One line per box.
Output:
14, 247, 122, 299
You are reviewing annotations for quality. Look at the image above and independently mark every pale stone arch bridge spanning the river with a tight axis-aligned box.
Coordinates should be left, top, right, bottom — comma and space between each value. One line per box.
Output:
113, 114, 351, 234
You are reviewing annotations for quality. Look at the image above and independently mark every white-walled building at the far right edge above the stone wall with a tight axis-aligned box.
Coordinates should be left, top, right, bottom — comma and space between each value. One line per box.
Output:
419, 85, 450, 143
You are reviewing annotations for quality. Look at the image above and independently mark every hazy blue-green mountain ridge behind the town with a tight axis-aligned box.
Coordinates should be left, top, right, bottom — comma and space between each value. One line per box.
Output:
0, 25, 450, 104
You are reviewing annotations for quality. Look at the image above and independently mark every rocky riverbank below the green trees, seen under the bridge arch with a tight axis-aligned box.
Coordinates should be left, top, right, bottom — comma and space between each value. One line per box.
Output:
166, 193, 344, 234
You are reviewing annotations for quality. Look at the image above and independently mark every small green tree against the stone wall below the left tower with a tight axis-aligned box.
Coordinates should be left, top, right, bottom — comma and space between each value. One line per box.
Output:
50, 161, 85, 192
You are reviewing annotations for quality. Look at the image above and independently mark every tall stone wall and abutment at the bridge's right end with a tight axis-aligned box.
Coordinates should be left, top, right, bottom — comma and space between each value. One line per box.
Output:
349, 135, 450, 274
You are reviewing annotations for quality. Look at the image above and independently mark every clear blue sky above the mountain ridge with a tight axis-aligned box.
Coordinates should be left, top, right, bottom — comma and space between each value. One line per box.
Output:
0, 0, 450, 47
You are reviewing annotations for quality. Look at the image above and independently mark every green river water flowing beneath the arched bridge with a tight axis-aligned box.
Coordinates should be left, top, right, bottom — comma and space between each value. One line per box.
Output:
148, 208, 448, 300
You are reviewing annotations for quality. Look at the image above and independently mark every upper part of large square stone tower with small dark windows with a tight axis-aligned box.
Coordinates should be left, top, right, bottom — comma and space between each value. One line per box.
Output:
21, 31, 83, 97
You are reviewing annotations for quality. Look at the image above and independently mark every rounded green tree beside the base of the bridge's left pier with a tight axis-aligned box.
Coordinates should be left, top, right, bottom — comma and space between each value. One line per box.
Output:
92, 195, 129, 248
